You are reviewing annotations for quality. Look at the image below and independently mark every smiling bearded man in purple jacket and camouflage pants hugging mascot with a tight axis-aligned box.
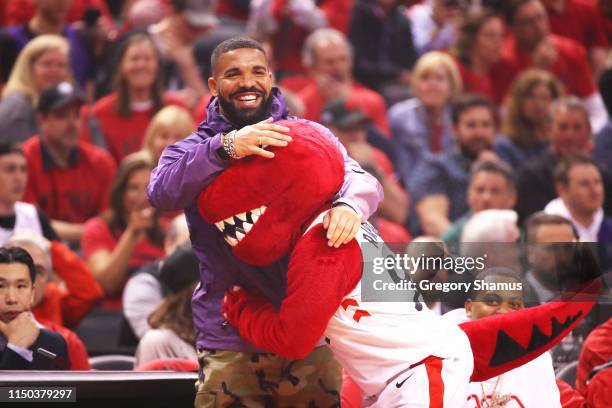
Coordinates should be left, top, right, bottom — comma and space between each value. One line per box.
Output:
149, 38, 382, 407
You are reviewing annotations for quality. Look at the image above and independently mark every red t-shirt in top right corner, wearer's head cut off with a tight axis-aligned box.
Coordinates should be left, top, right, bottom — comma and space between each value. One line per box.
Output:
546, 0, 608, 50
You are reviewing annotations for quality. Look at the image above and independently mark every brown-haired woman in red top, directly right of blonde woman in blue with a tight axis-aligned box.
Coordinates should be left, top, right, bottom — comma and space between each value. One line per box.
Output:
453, 12, 504, 101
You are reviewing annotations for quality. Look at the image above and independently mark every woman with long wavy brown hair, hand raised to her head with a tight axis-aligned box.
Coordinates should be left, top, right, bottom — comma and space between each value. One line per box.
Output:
495, 69, 563, 169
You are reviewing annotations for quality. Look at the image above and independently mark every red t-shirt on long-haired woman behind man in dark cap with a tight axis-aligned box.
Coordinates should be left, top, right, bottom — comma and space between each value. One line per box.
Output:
91, 92, 184, 163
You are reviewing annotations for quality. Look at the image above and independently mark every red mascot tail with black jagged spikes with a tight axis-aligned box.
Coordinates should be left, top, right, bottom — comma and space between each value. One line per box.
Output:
460, 279, 600, 381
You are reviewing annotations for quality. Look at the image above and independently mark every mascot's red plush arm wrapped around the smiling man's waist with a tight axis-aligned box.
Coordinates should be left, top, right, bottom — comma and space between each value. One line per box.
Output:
224, 225, 361, 359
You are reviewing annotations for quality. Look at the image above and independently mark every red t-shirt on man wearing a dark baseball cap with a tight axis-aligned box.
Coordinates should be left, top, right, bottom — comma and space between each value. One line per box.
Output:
23, 136, 116, 223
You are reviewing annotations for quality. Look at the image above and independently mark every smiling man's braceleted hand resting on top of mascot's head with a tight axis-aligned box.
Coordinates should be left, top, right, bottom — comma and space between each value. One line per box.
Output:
234, 118, 291, 159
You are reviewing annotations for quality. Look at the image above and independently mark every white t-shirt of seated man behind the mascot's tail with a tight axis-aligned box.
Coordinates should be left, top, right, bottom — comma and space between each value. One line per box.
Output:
444, 309, 561, 408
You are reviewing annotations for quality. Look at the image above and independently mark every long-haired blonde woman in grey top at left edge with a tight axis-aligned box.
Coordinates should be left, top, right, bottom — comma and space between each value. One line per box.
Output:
0, 35, 71, 142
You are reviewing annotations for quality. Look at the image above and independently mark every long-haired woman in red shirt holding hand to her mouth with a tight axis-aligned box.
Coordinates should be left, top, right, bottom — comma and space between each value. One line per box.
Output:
81, 152, 164, 309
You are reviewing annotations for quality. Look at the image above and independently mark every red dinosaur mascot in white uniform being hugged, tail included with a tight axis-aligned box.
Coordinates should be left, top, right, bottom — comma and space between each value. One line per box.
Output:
198, 121, 596, 408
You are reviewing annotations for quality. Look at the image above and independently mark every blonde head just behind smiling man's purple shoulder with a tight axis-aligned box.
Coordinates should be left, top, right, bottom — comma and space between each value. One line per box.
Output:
142, 105, 194, 164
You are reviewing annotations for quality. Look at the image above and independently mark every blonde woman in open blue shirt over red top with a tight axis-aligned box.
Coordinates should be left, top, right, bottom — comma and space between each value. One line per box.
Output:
389, 51, 462, 182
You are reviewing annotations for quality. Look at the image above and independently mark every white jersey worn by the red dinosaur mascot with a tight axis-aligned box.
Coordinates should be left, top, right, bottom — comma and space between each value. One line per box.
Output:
304, 217, 471, 395
